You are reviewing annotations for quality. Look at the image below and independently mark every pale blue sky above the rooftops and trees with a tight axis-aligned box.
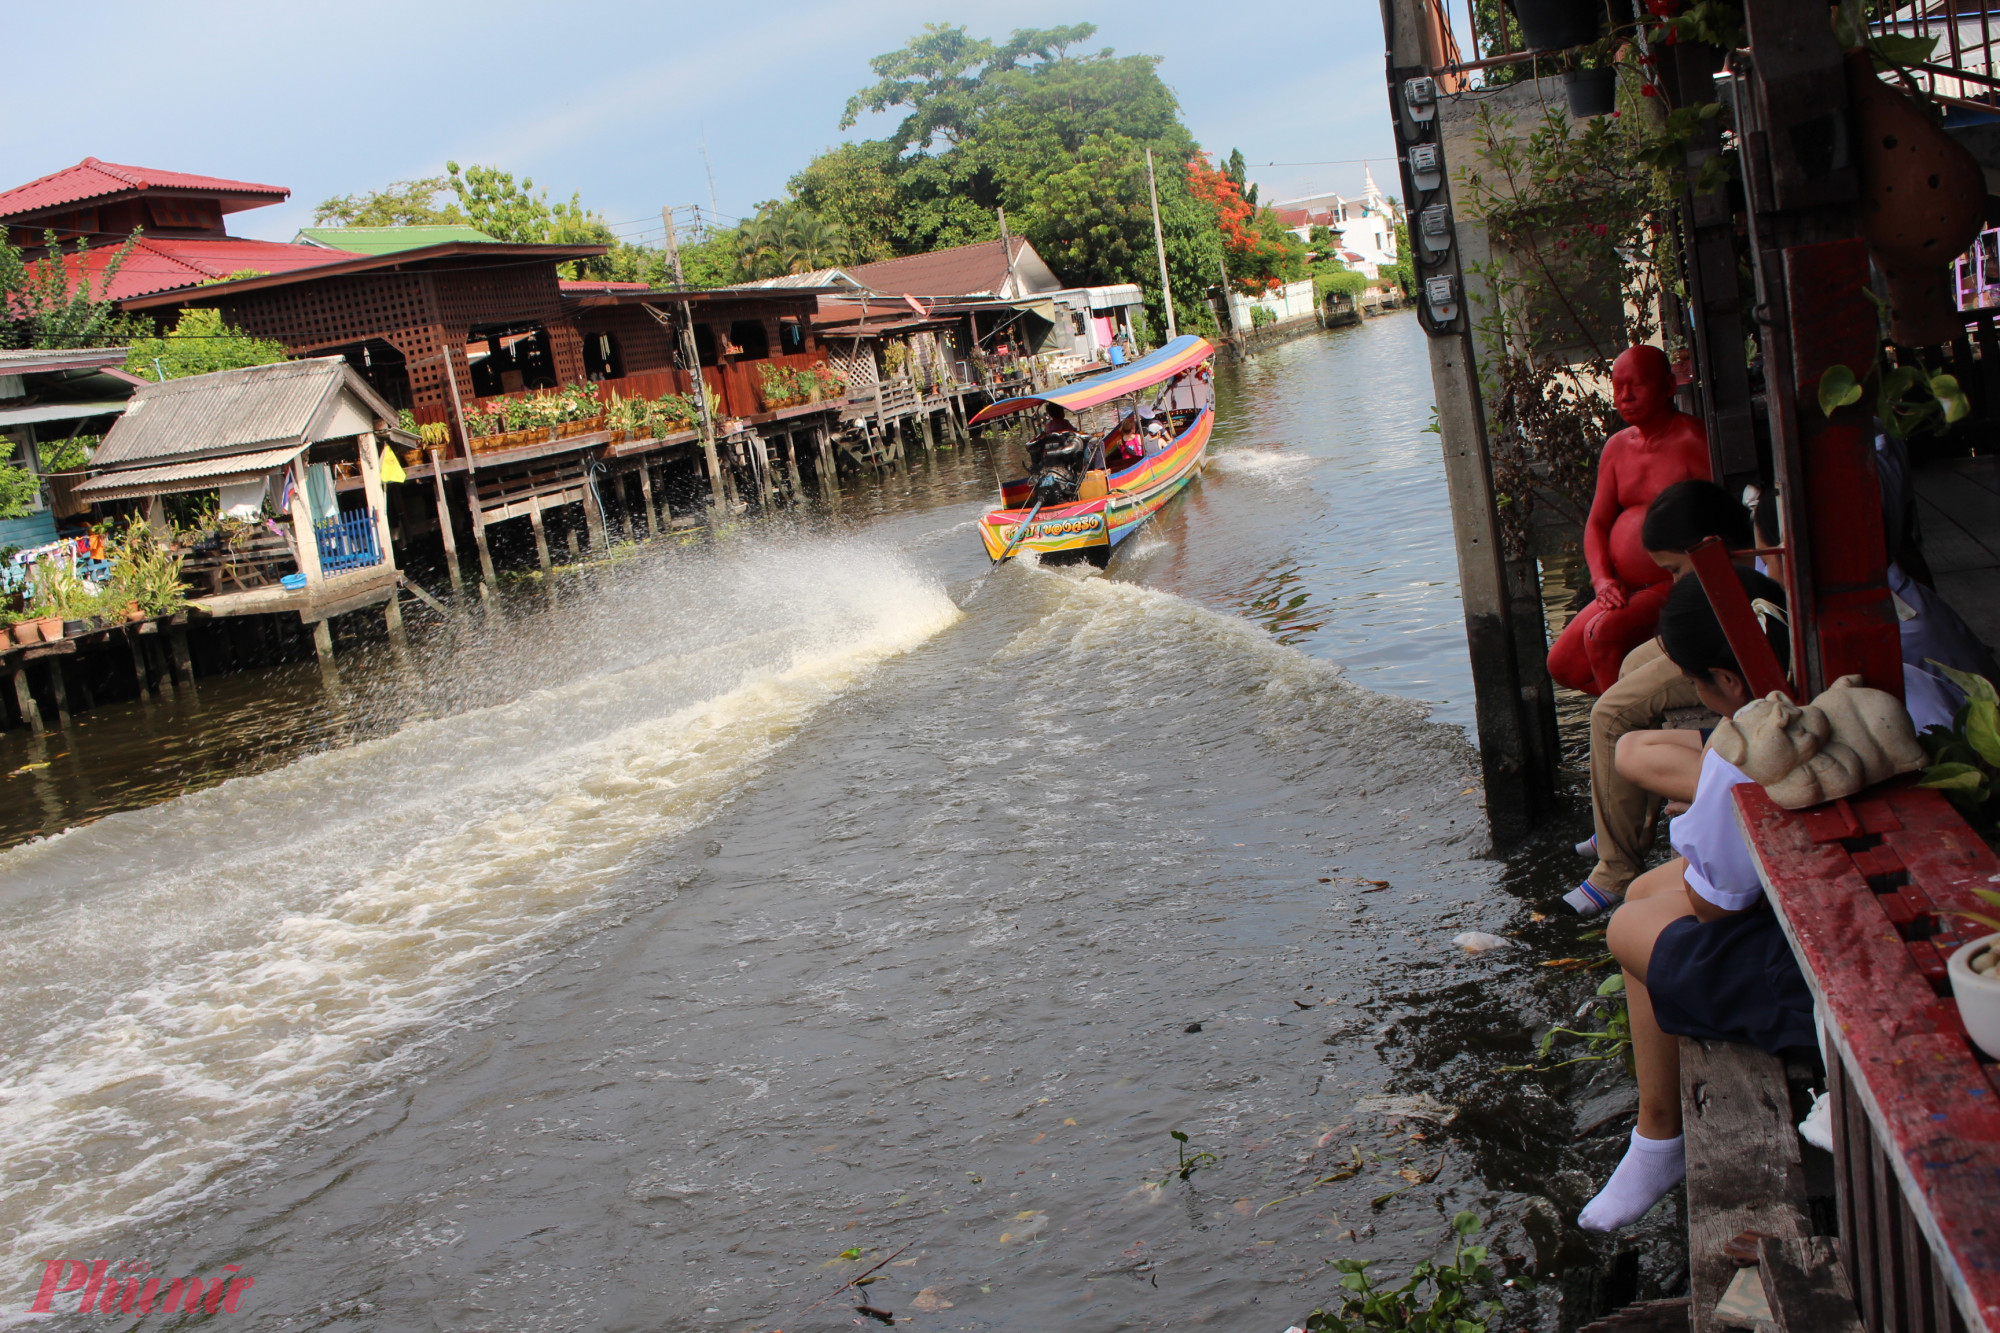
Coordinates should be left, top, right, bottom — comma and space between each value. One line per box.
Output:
0, 0, 1396, 249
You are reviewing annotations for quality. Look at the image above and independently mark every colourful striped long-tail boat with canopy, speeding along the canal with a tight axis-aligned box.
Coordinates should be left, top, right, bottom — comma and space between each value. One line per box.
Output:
972, 334, 1216, 564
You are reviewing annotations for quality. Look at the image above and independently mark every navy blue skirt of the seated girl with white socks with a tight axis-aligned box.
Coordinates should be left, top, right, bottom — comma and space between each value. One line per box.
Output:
1646, 899, 1820, 1055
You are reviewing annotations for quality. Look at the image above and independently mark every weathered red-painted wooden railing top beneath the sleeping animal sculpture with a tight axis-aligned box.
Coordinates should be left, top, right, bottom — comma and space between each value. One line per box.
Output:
1734, 783, 2000, 1331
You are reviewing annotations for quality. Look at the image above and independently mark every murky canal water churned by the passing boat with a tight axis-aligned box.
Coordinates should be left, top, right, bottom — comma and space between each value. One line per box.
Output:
0, 314, 1680, 1333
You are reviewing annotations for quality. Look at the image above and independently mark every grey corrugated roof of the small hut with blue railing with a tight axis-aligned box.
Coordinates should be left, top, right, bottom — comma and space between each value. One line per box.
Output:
90, 356, 396, 470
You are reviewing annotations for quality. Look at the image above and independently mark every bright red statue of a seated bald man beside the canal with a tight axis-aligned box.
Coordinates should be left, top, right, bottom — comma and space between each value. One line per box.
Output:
1548, 346, 1710, 695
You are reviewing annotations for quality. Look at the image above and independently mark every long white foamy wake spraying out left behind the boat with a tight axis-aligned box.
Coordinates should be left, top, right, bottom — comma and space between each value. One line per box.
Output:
0, 546, 958, 1267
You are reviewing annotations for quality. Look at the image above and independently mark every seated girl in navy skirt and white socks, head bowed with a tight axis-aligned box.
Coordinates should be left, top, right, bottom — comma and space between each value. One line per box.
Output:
1576, 566, 1818, 1231
